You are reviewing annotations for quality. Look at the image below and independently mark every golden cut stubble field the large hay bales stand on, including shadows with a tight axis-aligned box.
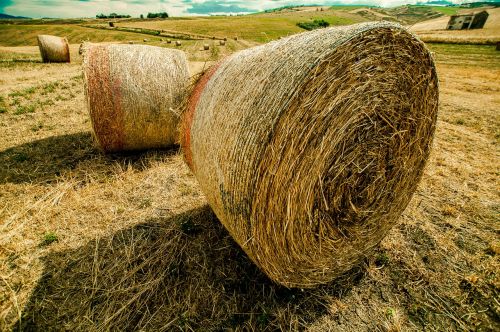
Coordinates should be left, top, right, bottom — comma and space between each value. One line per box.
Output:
0, 22, 500, 331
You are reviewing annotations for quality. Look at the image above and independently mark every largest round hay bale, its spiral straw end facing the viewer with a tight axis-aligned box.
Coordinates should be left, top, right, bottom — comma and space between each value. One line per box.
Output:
182, 22, 438, 287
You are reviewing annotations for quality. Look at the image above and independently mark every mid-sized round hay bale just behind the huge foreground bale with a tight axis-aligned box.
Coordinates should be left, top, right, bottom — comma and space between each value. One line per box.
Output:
83, 44, 189, 152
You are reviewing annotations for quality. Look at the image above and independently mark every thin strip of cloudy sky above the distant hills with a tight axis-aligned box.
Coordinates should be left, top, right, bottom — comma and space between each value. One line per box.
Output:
0, 0, 480, 17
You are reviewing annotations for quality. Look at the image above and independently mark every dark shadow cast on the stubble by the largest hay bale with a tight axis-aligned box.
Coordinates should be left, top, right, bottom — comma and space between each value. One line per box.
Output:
14, 206, 364, 331
